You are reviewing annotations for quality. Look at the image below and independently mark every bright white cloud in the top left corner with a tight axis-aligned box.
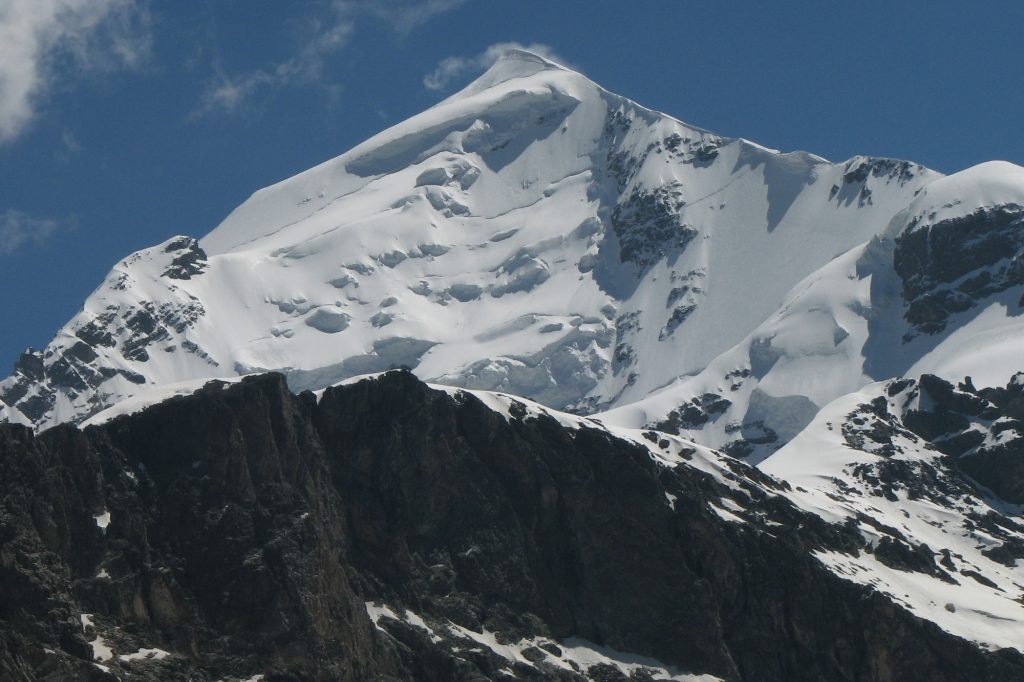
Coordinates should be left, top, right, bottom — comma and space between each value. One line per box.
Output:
0, 0, 151, 143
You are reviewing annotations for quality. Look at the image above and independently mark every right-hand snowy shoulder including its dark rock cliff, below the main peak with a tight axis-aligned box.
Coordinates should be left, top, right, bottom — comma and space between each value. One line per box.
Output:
604, 157, 1024, 461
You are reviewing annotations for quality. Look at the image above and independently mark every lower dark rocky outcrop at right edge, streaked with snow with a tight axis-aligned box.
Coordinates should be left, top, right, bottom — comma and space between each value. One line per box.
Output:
840, 373, 1024, 573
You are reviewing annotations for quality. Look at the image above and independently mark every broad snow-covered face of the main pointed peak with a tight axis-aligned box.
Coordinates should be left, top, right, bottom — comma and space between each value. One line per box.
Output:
0, 51, 938, 427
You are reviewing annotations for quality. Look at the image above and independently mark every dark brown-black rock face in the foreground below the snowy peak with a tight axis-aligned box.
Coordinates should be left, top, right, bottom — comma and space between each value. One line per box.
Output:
0, 372, 1024, 681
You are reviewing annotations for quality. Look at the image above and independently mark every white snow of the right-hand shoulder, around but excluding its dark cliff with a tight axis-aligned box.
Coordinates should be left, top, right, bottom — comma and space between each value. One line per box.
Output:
601, 157, 1024, 462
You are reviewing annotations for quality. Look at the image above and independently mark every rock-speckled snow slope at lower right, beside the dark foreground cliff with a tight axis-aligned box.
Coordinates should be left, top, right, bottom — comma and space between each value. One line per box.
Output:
760, 381, 1024, 649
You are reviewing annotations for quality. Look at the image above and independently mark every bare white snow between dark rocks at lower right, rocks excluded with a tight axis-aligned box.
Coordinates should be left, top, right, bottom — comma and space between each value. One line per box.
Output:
759, 383, 1024, 650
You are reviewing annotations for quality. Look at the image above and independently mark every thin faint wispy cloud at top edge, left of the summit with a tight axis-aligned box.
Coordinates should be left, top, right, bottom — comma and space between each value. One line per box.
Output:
189, 0, 467, 119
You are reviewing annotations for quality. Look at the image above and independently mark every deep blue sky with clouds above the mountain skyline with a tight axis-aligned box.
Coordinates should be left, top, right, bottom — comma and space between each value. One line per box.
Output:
0, 0, 1024, 368
